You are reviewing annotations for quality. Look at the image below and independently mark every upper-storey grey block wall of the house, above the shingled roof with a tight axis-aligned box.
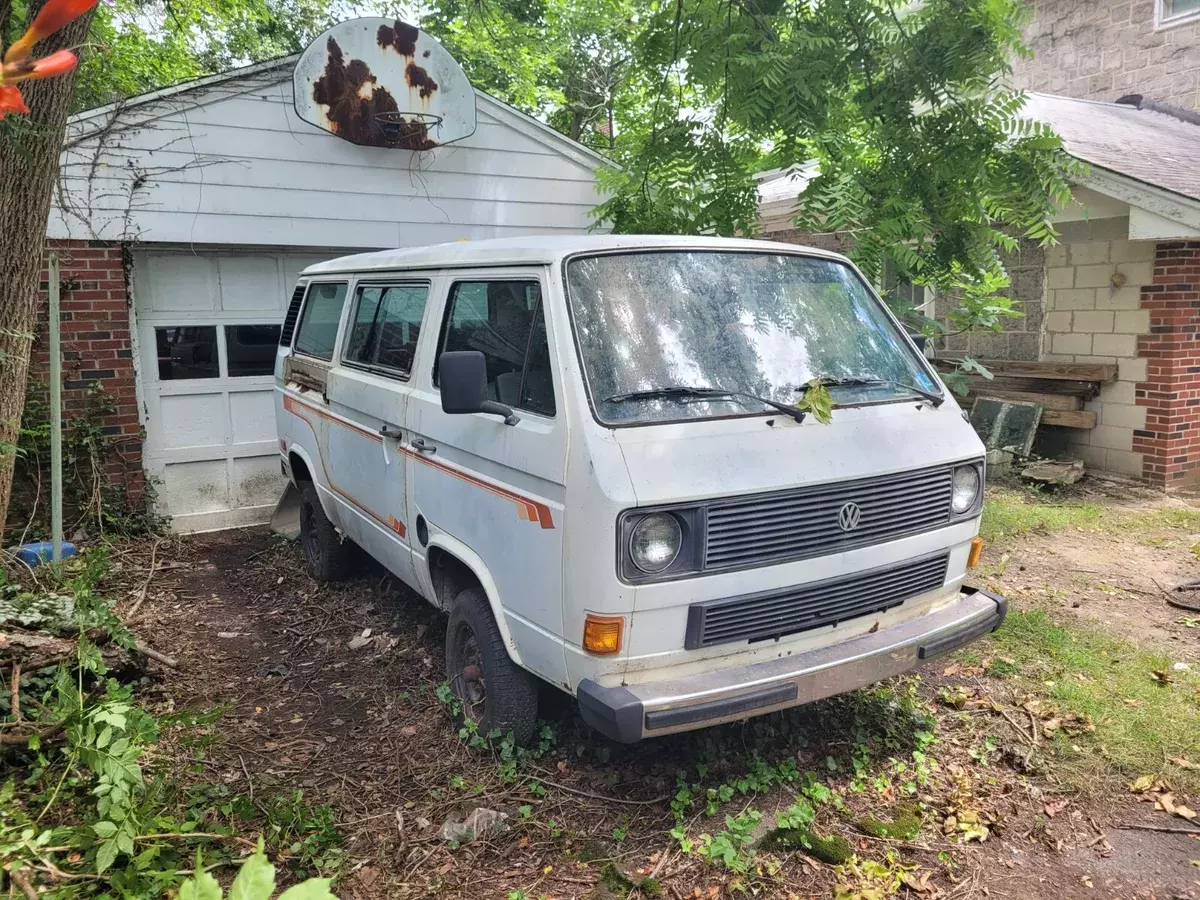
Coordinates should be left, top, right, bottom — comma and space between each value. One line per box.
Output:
1013, 0, 1200, 110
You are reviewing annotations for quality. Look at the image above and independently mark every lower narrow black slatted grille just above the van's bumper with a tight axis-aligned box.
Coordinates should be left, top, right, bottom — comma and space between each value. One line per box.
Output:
684, 553, 950, 650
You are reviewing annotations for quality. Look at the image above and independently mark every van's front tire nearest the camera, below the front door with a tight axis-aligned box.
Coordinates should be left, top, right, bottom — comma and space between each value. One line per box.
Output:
446, 587, 538, 744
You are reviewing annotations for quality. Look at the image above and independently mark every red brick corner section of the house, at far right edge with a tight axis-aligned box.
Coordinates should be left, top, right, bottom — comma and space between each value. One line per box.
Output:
1134, 241, 1200, 488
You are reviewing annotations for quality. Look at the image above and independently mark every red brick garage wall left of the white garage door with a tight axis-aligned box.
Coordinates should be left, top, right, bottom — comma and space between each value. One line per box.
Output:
30, 241, 143, 497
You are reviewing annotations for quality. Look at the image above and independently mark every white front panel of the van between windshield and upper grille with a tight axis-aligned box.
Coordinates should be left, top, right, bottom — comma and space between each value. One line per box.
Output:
616, 397, 984, 506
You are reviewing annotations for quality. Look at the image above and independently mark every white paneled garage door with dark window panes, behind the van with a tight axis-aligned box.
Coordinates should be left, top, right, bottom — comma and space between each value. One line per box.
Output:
133, 251, 336, 532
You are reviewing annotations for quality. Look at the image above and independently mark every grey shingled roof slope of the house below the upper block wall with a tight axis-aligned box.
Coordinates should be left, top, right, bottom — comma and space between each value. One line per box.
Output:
1022, 92, 1200, 200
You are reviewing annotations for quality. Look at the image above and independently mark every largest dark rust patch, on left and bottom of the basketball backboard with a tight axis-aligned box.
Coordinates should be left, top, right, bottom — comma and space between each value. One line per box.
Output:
312, 37, 437, 150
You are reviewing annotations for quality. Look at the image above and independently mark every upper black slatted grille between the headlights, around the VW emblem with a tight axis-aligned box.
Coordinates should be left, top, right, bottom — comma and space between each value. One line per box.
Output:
704, 466, 952, 571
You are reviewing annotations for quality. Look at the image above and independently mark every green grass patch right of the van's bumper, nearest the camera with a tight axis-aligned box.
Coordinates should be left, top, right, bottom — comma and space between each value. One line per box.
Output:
974, 610, 1200, 790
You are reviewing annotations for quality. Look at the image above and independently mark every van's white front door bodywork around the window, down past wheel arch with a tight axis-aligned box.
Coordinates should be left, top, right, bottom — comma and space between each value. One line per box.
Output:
404, 268, 569, 688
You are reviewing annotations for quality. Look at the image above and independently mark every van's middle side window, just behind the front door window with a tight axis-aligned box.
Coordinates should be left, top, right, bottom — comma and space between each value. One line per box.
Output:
346, 284, 430, 374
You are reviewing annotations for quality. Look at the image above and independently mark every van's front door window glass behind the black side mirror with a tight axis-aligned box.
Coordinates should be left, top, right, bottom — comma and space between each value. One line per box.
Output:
433, 281, 554, 416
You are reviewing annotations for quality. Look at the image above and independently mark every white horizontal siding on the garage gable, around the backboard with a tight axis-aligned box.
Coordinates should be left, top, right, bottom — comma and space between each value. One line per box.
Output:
49, 65, 600, 250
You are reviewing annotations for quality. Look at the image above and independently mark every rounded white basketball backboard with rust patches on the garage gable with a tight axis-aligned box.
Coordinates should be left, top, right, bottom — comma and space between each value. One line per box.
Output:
293, 18, 475, 150
